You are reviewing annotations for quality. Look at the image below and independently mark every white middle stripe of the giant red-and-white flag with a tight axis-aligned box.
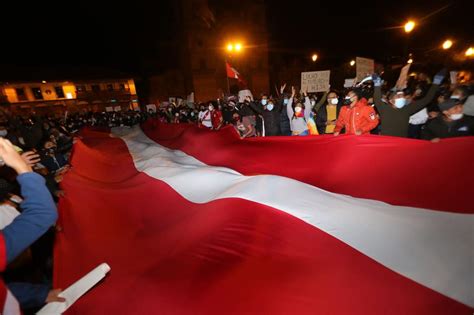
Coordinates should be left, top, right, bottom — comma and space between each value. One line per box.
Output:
113, 127, 474, 306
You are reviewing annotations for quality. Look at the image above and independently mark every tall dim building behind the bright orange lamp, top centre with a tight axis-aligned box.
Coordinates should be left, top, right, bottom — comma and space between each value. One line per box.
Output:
148, 0, 269, 102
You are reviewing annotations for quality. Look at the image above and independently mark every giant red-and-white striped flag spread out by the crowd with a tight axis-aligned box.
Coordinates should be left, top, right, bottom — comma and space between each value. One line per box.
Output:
55, 121, 474, 315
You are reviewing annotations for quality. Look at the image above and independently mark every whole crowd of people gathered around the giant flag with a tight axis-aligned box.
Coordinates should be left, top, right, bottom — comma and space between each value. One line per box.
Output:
0, 67, 474, 310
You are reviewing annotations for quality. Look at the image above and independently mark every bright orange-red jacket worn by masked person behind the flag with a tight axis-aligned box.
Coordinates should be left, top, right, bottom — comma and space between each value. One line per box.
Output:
334, 98, 379, 135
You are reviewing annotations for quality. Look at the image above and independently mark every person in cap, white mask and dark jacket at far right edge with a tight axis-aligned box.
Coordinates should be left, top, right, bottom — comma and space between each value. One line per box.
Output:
421, 99, 474, 142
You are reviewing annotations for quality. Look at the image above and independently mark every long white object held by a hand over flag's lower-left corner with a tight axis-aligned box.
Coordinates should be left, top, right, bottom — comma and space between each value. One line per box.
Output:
36, 263, 110, 315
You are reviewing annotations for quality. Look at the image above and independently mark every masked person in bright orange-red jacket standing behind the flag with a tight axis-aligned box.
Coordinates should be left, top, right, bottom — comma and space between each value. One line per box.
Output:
334, 89, 379, 136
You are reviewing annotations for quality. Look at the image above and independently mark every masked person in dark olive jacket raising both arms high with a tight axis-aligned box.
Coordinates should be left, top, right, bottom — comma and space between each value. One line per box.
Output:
372, 70, 446, 138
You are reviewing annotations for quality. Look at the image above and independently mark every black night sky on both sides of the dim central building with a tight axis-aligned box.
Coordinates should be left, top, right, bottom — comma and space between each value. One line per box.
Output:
0, 0, 474, 79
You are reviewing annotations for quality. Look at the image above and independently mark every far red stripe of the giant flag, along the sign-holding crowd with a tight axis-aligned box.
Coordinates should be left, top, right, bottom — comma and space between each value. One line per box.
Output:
142, 121, 474, 213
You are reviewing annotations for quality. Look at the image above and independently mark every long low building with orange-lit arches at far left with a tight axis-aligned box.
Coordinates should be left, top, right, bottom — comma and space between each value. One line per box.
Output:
0, 79, 139, 115
